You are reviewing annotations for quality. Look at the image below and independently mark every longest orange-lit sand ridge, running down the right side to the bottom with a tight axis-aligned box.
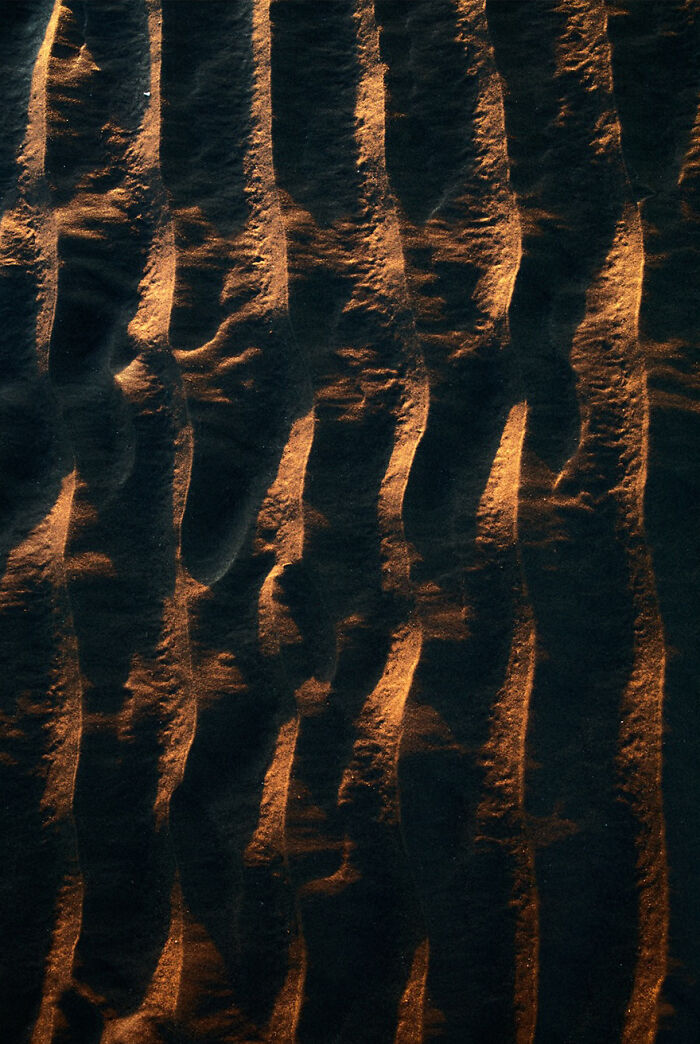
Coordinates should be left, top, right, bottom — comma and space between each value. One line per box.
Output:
574, 194, 669, 1042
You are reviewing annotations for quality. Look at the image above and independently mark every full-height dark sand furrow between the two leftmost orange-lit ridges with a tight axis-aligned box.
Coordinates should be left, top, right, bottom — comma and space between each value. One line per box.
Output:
37, 3, 189, 1035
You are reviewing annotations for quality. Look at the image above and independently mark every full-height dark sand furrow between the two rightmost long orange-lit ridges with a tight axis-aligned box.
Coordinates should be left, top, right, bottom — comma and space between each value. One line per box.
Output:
482, 3, 658, 1039
